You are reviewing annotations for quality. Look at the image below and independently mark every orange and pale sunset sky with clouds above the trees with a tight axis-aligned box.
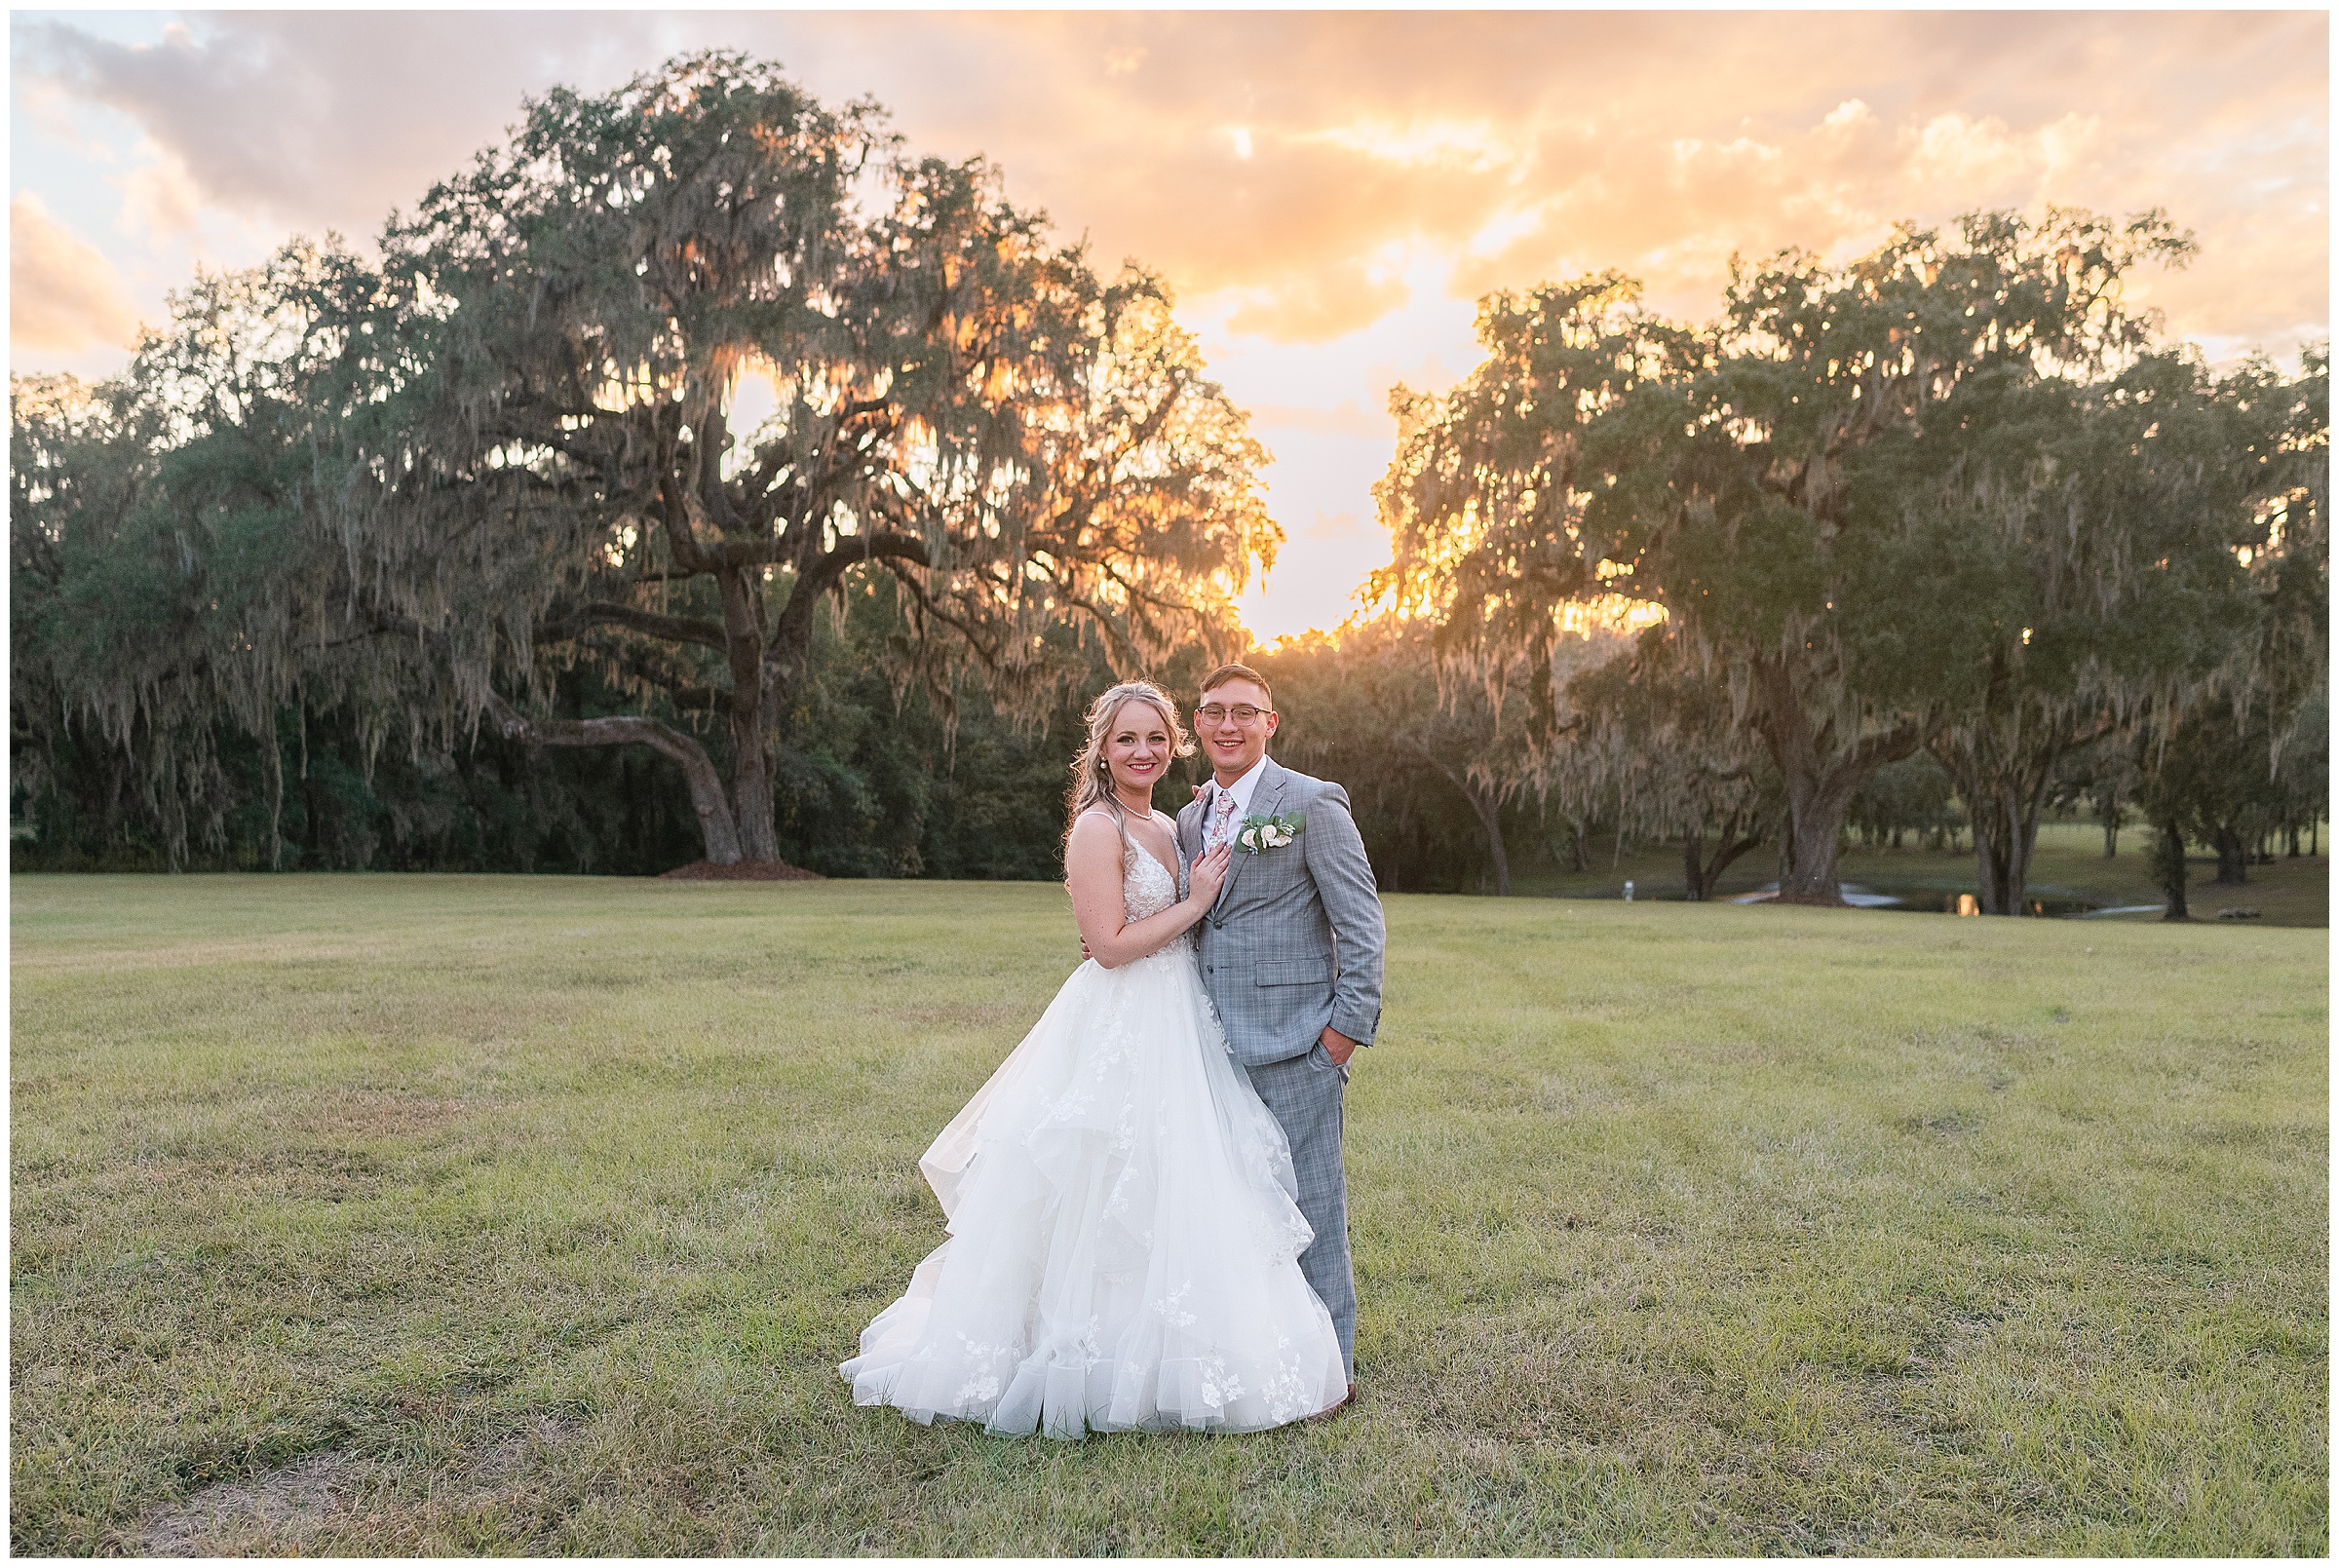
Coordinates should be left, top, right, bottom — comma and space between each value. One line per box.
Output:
10, 12, 2329, 639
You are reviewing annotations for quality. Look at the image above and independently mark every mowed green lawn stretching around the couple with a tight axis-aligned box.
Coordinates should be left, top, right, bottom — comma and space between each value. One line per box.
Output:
10, 878, 2329, 1556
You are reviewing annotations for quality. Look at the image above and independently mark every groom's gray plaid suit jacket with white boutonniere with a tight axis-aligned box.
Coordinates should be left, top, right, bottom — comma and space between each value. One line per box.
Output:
1176, 758, 1382, 1067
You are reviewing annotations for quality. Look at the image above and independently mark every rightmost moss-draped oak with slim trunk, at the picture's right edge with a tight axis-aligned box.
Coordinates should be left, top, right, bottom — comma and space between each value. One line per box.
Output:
1930, 351, 2320, 915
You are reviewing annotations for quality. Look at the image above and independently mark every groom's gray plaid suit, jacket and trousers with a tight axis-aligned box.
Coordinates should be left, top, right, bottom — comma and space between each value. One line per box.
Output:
1176, 758, 1382, 1381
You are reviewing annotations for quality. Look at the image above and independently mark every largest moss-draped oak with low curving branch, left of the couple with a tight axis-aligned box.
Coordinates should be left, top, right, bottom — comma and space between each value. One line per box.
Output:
318, 54, 1280, 863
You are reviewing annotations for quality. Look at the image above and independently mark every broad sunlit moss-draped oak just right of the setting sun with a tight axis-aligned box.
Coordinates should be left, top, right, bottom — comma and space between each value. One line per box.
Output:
1375, 209, 2273, 903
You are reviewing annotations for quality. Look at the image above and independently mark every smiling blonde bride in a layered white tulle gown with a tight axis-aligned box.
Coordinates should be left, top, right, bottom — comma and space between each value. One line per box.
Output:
842, 681, 1347, 1437
